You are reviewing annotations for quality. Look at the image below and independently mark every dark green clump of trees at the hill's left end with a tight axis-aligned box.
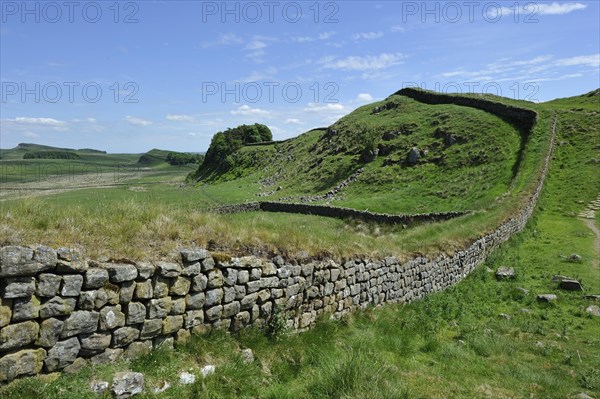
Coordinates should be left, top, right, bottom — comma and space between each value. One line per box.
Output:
201, 123, 273, 168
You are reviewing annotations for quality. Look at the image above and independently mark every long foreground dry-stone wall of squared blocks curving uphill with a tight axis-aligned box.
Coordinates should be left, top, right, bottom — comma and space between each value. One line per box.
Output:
0, 108, 554, 382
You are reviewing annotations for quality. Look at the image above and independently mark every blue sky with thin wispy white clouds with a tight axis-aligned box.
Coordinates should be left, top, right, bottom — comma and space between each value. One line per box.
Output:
0, 0, 600, 152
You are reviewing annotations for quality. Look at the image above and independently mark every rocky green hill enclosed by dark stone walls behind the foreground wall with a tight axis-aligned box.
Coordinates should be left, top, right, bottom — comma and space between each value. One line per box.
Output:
194, 88, 533, 213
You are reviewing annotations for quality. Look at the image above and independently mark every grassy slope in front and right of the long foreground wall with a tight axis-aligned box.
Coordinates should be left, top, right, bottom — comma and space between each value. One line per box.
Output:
0, 93, 600, 399
